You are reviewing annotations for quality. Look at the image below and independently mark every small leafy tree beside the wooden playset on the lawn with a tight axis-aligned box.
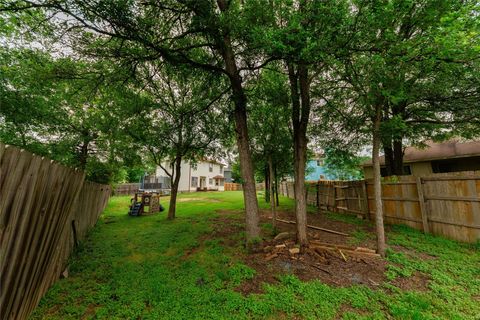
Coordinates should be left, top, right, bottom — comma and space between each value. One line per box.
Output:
124, 65, 228, 219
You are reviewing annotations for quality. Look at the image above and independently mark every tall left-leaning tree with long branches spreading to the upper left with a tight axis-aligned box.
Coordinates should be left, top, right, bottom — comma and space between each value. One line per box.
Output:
0, 0, 272, 243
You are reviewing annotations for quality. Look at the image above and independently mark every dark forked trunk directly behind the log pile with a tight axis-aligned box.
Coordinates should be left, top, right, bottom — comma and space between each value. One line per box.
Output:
287, 63, 310, 248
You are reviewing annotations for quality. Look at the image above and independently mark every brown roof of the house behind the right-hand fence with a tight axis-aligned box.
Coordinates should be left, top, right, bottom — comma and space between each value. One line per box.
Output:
363, 140, 480, 167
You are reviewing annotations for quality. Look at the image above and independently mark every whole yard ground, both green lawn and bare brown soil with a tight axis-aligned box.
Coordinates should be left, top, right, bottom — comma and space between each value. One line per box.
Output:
32, 191, 480, 319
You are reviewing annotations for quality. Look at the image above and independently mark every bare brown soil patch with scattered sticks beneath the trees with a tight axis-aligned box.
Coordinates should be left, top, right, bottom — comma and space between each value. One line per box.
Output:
207, 210, 432, 295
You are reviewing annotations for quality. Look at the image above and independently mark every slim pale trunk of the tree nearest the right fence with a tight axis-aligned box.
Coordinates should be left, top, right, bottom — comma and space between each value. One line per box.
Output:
372, 106, 385, 257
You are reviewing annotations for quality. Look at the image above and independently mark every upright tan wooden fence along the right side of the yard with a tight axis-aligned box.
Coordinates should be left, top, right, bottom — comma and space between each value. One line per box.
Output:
280, 174, 480, 242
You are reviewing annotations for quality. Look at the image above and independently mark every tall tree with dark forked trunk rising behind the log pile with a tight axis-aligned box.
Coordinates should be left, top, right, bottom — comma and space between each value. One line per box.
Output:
248, 0, 347, 247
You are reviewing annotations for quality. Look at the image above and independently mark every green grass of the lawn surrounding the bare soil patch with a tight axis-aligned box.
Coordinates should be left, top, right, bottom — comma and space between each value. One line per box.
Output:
32, 192, 480, 319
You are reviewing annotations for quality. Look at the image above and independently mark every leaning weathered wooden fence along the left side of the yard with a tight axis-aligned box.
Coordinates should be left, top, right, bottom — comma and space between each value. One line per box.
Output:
0, 143, 111, 319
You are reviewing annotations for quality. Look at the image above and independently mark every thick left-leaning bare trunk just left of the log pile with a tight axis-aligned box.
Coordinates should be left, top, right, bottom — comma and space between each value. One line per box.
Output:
217, 0, 260, 242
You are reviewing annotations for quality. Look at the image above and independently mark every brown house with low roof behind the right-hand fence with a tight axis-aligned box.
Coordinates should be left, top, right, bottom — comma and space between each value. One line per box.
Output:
363, 140, 480, 179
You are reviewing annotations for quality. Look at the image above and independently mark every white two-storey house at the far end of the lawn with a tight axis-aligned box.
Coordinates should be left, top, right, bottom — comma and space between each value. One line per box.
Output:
149, 159, 225, 192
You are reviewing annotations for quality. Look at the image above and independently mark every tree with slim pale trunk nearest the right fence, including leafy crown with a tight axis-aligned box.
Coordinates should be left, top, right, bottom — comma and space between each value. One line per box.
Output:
327, 0, 480, 255
